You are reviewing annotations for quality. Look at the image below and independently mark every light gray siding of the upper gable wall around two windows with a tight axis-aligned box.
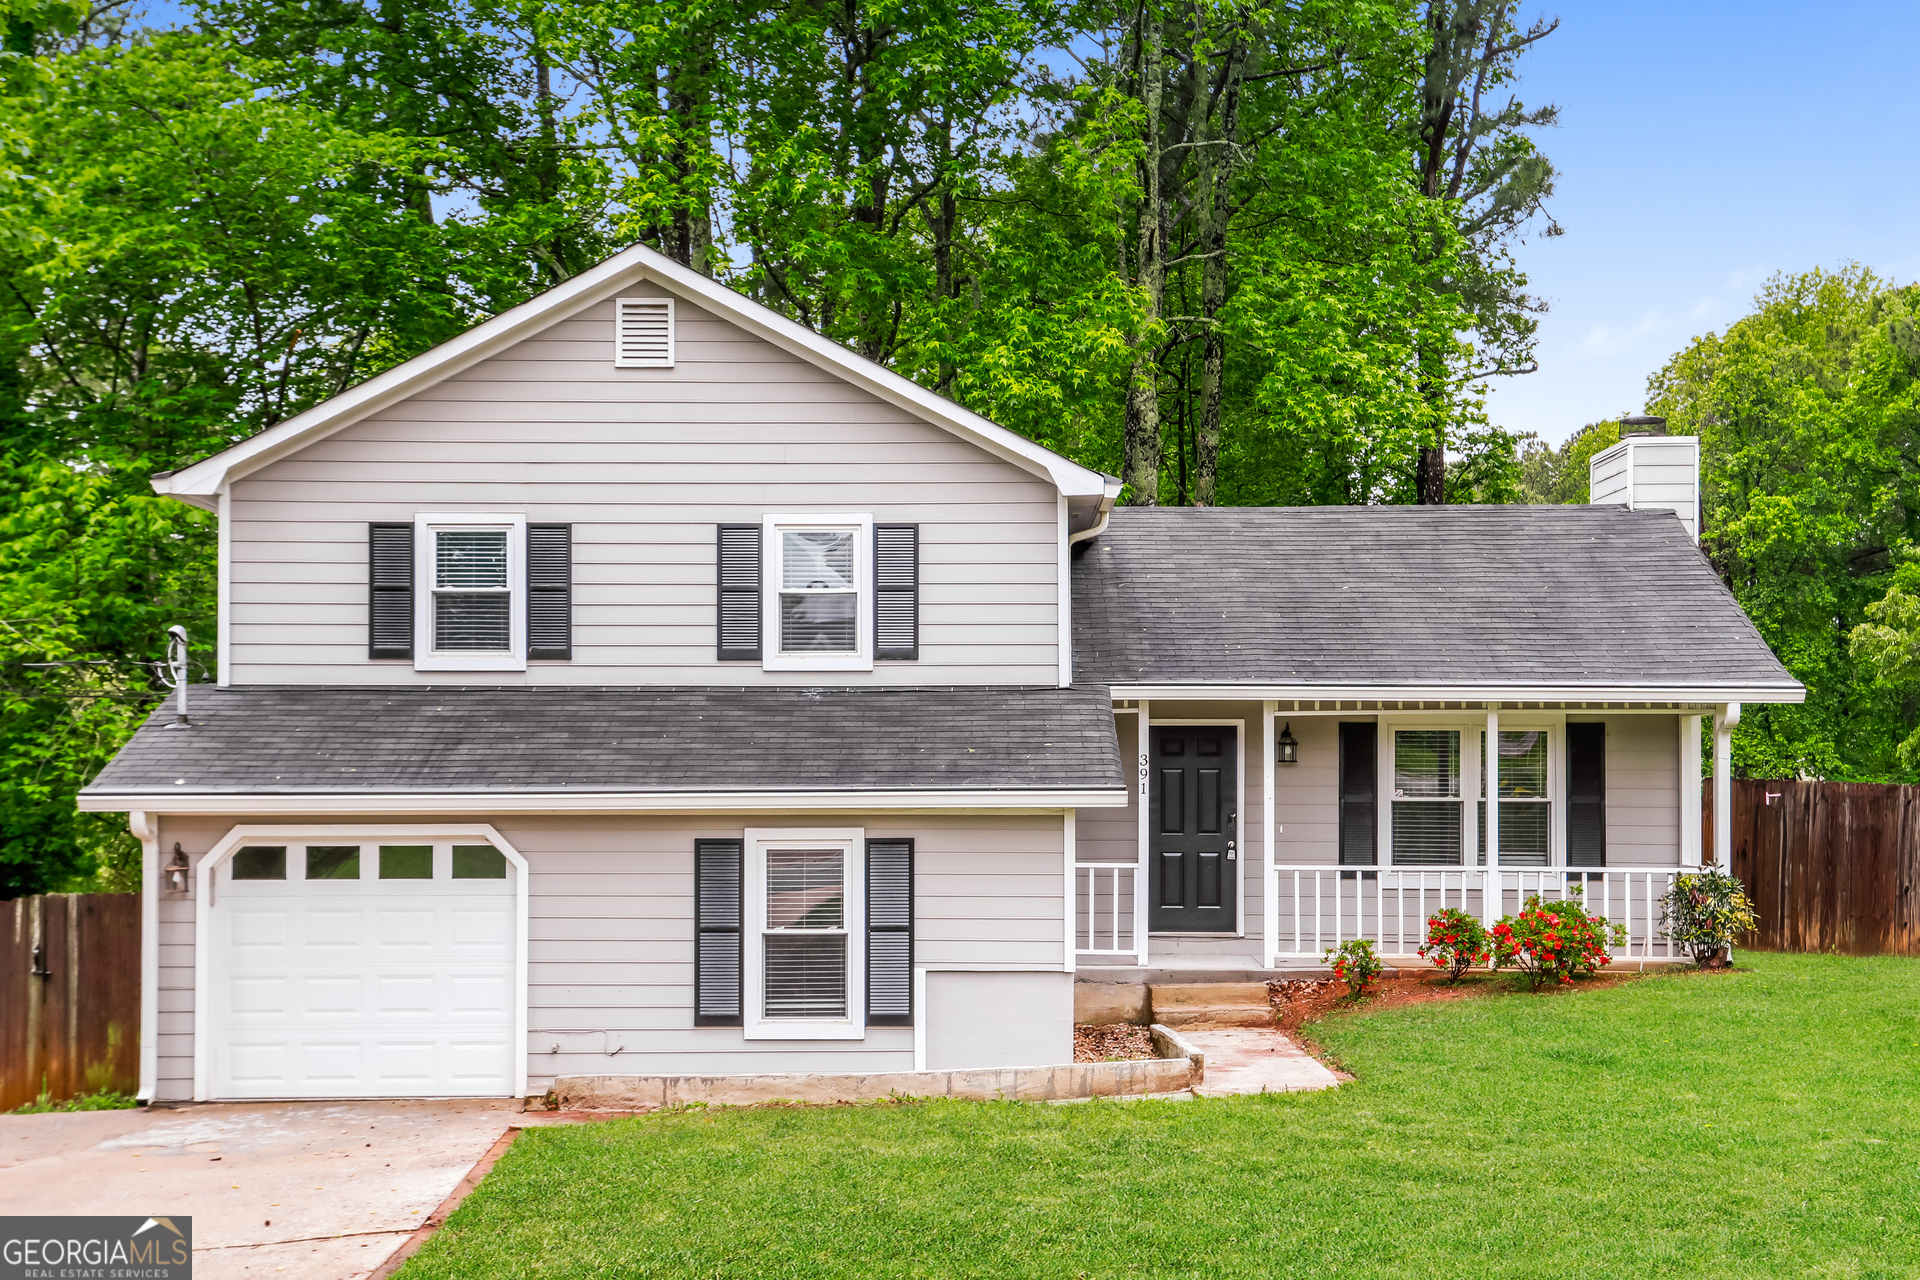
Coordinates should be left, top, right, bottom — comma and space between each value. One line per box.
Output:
228, 282, 1060, 685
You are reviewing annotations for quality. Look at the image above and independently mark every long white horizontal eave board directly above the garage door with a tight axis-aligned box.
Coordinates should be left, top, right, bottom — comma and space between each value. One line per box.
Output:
79, 787, 1127, 816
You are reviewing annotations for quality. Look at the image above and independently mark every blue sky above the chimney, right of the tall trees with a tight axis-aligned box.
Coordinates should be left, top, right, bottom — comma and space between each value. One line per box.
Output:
1488, 0, 1920, 443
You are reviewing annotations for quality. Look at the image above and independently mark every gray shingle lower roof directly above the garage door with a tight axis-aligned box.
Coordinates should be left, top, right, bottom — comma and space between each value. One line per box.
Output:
86, 683, 1123, 796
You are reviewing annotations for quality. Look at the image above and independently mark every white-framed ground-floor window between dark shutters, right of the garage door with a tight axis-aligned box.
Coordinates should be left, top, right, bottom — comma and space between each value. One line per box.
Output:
743, 831, 866, 1040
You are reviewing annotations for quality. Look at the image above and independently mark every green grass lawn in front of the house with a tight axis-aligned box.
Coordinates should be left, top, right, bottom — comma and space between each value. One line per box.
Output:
399, 952, 1920, 1280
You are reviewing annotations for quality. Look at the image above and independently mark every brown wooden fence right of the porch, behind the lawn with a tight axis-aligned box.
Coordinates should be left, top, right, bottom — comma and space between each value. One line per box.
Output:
1701, 777, 1920, 956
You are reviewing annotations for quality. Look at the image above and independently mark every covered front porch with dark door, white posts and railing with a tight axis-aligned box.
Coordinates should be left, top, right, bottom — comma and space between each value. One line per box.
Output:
1071, 697, 1738, 983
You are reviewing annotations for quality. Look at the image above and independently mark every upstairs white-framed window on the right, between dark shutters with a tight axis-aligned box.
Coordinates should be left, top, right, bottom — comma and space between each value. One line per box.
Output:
760, 514, 874, 672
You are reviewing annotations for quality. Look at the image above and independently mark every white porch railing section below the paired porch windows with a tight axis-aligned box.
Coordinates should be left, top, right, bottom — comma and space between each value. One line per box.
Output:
1269, 864, 1682, 960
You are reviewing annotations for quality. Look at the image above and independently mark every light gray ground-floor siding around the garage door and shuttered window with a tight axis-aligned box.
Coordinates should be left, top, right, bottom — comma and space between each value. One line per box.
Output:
159, 814, 1071, 1098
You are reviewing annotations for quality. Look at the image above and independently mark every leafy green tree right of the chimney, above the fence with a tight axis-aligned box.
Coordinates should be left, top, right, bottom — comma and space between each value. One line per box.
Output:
1647, 267, 1920, 781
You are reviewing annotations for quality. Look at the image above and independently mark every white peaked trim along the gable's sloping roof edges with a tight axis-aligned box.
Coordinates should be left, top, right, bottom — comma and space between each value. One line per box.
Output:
152, 244, 1106, 510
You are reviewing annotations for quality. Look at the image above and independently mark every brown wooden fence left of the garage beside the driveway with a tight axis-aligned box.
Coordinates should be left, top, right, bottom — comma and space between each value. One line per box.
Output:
0, 894, 140, 1111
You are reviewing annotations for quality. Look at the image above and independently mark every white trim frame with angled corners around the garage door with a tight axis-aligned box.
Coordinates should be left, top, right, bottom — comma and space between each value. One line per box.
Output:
190, 818, 528, 1102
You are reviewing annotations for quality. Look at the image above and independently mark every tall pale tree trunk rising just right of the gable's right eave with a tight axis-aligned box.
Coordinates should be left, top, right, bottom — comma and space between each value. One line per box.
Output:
1119, 8, 1167, 507
